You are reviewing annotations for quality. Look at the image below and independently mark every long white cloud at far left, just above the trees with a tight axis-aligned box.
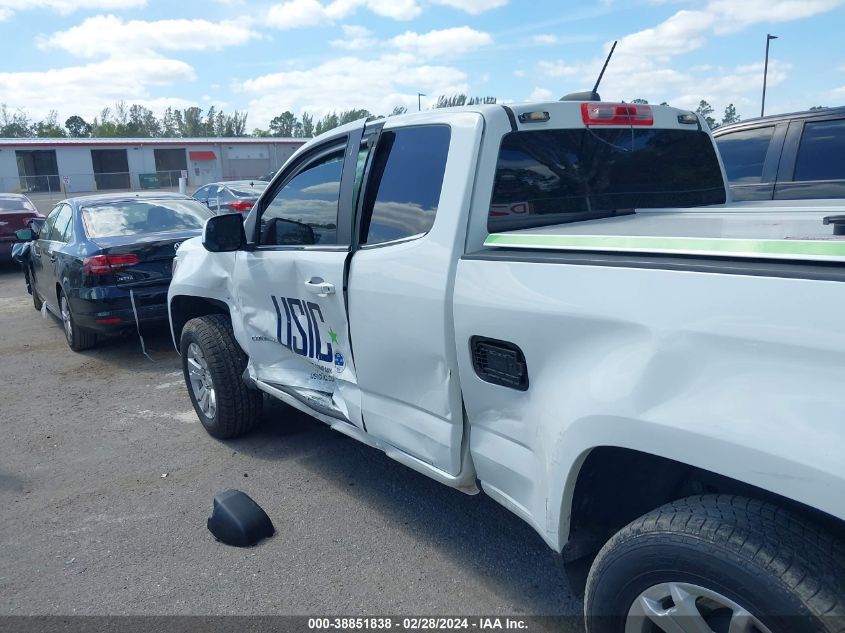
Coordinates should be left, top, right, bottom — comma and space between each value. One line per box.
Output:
0, 55, 196, 120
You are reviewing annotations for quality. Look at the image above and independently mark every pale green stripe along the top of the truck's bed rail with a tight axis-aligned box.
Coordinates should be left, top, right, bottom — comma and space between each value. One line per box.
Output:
484, 233, 845, 257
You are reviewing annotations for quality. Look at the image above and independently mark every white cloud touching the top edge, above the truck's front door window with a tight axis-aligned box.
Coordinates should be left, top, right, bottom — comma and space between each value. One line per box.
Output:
267, 0, 422, 29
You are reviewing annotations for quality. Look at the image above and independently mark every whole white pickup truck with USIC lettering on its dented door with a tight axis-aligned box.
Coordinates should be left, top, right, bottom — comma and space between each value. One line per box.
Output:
168, 100, 845, 633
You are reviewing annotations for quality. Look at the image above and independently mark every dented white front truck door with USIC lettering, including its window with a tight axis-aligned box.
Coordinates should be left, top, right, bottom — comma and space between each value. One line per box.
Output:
234, 124, 363, 425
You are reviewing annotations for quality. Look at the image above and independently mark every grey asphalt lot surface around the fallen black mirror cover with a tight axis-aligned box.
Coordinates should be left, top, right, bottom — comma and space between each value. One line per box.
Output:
0, 265, 581, 630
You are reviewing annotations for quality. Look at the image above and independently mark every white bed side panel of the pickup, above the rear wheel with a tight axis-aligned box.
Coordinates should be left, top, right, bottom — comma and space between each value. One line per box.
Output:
455, 261, 845, 549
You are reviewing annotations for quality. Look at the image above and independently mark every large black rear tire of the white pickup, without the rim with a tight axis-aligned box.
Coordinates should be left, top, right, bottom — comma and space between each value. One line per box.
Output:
584, 495, 845, 633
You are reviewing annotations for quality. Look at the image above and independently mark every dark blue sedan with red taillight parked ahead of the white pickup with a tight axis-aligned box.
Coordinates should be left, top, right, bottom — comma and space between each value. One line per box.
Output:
19, 192, 213, 351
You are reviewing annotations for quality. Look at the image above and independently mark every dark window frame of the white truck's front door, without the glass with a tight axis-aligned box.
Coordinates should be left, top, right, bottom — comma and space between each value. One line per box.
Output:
247, 124, 364, 251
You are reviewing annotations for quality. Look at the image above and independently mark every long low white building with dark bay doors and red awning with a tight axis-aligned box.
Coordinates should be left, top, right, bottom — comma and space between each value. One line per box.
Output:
0, 137, 305, 194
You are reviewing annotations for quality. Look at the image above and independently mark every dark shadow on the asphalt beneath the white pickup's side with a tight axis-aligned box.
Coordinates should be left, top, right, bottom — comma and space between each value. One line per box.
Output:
226, 400, 583, 616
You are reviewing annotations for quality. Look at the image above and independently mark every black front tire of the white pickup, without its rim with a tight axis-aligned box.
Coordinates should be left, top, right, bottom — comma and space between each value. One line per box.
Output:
179, 314, 264, 439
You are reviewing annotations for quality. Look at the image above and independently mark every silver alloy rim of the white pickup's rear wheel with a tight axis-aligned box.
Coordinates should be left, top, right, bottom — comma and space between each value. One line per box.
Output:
625, 582, 771, 633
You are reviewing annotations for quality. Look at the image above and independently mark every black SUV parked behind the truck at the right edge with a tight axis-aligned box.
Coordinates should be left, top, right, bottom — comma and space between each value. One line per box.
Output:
713, 107, 845, 200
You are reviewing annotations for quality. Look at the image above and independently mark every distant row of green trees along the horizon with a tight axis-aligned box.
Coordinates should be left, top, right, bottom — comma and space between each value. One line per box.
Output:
0, 94, 822, 138
